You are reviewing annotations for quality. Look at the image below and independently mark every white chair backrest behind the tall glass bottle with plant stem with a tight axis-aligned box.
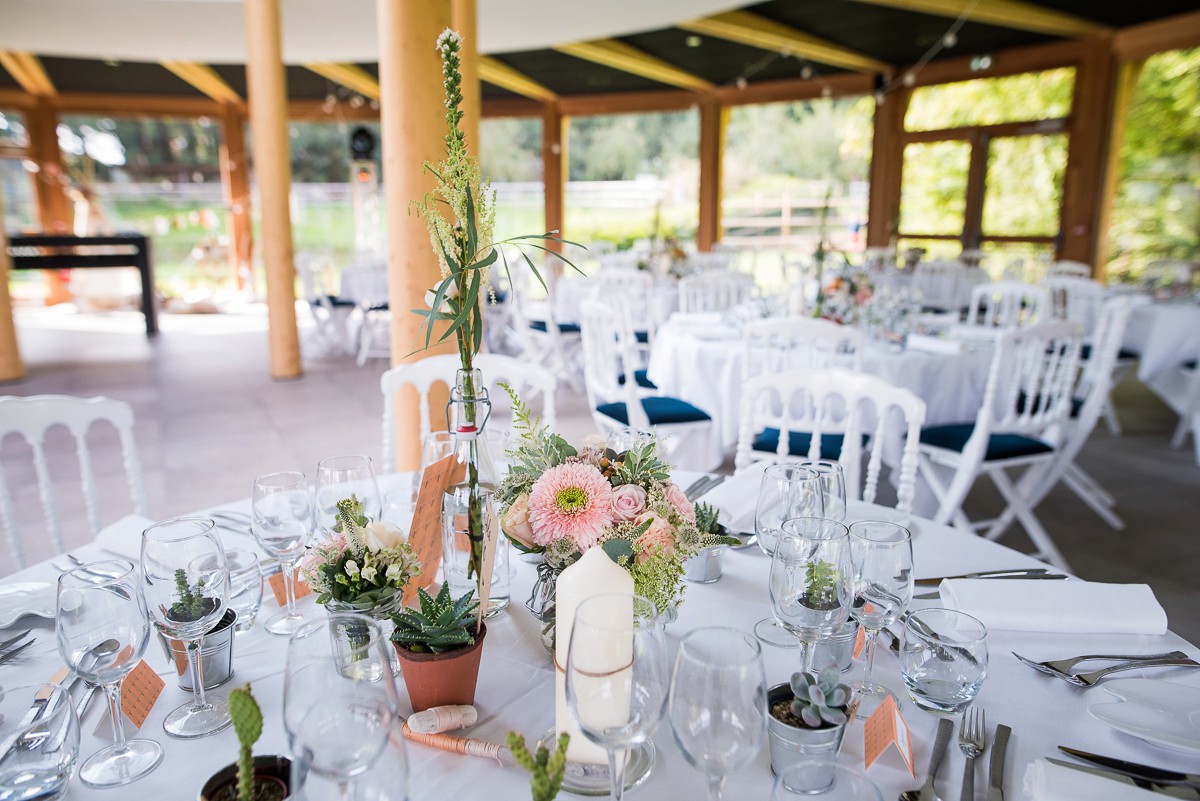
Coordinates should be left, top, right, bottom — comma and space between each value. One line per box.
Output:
379, 354, 558, 472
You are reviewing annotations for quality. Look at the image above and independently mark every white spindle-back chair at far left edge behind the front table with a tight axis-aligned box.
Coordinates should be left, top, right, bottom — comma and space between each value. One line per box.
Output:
0, 395, 146, 567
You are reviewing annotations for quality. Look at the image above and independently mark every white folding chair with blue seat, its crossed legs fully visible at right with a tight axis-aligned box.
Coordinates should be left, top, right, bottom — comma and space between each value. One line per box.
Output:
920, 321, 1082, 570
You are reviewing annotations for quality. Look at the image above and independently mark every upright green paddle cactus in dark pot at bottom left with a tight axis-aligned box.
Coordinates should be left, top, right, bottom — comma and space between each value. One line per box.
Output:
199, 685, 292, 801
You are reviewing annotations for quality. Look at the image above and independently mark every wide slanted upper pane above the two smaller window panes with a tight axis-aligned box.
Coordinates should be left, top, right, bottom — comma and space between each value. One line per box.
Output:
905, 67, 1075, 131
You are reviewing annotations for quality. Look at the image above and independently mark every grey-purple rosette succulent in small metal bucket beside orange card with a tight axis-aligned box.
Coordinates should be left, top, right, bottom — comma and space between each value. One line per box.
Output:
767, 669, 857, 793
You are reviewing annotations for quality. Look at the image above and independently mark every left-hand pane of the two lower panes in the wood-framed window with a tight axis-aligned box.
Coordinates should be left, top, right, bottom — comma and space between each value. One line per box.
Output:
900, 140, 971, 236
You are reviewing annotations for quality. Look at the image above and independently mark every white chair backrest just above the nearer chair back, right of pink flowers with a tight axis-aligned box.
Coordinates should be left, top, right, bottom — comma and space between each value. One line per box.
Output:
742, 317, 864, 380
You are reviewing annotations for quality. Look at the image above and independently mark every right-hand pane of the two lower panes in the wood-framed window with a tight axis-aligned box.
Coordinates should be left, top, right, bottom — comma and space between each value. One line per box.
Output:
983, 134, 1067, 236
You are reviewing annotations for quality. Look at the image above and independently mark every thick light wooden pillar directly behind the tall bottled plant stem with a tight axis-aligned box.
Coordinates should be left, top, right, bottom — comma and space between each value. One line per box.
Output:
378, 0, 451, 470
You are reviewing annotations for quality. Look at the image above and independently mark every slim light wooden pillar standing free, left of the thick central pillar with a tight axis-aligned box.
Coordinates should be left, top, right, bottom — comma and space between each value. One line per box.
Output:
245, 0, 304, 379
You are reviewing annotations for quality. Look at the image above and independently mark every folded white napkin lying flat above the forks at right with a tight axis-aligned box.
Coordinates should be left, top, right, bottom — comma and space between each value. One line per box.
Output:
940, 578, 1166, 634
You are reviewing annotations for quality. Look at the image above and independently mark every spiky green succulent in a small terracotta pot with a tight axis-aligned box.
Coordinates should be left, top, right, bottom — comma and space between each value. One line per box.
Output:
391, 582, 487, 712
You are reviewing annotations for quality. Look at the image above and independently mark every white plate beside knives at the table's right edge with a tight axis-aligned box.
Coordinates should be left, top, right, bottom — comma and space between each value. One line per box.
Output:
1087, 679, 1200, 753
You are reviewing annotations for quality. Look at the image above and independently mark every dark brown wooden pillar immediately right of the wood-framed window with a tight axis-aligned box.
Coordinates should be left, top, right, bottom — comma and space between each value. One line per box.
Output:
1057, 37, 1117, 266
